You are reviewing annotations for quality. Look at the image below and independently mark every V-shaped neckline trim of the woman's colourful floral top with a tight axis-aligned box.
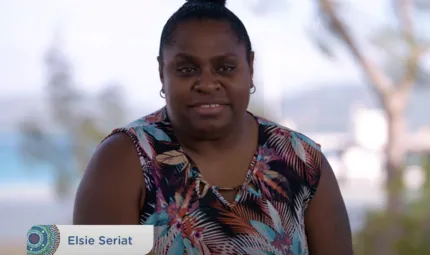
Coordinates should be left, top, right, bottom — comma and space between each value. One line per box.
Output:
171, 111, 261, 209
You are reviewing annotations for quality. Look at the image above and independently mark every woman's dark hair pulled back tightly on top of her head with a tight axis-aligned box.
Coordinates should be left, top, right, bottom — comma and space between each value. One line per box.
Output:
159, 0, 252, 60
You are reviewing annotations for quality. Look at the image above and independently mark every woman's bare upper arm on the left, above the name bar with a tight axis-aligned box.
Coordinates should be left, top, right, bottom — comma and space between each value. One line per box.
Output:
73, 133, 144, 225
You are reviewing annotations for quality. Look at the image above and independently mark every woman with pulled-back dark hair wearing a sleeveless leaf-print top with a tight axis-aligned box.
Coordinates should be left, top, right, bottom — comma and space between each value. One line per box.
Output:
74, 0, 352, 255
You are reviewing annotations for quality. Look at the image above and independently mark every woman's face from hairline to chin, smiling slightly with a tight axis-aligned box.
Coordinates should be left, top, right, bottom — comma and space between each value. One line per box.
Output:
159, 20, 254, 138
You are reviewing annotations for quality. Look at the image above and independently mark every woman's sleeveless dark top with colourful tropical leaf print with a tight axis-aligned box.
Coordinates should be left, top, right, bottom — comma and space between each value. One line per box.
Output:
109, 108, 321, 255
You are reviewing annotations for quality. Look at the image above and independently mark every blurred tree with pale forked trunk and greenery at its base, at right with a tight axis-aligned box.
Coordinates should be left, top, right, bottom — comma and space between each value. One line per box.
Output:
311, 0, 430, 255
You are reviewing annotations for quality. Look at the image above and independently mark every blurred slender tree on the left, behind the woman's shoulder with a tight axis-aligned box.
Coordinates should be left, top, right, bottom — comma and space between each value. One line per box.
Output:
20, 37, 125, 200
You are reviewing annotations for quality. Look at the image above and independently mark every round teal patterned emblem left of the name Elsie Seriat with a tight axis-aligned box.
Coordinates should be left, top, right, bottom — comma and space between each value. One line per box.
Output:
27, 225, 60, 255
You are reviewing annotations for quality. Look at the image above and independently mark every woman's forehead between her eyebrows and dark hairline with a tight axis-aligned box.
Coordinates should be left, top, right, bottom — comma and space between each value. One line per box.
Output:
164, 20, 246, 58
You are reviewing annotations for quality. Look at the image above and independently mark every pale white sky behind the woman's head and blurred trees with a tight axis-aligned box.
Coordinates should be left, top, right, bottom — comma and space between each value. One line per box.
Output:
0, 0, 392, 113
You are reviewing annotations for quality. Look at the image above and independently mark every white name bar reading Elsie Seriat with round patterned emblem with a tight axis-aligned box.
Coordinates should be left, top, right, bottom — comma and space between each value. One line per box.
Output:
27, 225, 154, 255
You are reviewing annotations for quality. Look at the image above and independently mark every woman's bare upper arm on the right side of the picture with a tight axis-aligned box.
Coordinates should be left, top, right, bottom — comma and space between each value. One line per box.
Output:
305, 153, 353, 255
